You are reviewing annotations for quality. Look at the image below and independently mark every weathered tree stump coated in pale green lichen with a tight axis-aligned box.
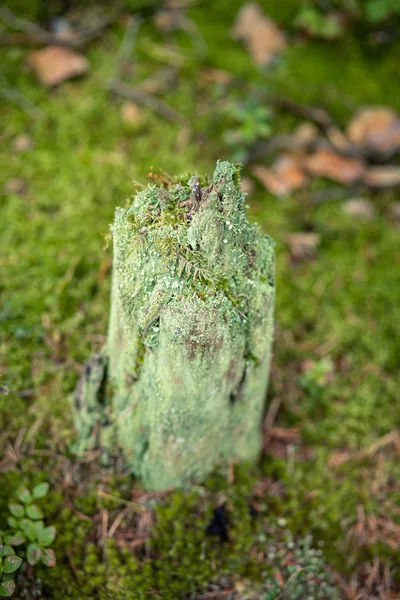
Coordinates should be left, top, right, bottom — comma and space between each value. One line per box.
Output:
75, 162, 275, 489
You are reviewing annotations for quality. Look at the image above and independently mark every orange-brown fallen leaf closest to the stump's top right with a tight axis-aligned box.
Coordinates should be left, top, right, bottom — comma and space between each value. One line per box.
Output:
252, 154, 308, 196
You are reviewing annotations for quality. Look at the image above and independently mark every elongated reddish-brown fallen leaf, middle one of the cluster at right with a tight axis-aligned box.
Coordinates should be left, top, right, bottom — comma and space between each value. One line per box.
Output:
306, 148, 365, 183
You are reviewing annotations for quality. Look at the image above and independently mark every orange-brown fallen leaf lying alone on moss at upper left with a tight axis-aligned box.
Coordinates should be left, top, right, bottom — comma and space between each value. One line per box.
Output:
27, 46, 89, 87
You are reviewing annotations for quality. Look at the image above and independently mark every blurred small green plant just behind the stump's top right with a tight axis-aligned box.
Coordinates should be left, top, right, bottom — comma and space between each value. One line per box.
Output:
224, 98, 272, 161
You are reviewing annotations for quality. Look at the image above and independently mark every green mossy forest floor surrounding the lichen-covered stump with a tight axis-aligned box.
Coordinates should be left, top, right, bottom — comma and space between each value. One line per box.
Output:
0, 0, 400, 600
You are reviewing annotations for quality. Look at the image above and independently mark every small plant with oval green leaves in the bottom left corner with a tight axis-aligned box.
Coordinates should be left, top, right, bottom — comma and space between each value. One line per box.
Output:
5, 482, 56, 567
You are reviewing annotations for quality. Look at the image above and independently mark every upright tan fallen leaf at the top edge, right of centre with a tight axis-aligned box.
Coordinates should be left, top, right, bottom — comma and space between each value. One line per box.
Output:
232, 2, 286, 65
